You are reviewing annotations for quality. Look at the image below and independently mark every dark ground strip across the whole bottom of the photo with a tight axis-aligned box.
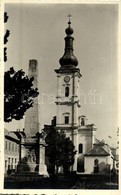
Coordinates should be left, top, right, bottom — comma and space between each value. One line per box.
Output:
4, 175, 118, 189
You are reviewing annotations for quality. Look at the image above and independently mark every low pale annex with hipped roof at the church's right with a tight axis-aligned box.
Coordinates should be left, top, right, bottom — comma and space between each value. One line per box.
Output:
84, 142, 115, 174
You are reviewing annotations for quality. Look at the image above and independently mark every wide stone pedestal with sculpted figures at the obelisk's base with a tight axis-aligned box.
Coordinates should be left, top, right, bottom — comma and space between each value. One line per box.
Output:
18, 137, 48, 176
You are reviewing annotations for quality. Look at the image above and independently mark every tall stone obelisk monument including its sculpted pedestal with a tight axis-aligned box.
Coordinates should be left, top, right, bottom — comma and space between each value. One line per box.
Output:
19, 60, 48, 175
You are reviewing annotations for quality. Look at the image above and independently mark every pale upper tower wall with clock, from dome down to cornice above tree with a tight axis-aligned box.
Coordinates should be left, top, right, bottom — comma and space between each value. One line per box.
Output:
56, 73, 79, 126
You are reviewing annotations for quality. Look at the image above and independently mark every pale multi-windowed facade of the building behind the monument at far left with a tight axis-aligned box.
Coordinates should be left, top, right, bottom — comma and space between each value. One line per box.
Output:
4, 138, 19, 173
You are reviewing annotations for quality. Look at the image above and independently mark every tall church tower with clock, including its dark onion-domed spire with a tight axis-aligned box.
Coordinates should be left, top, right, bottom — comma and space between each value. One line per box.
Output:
55, 19, 81, 171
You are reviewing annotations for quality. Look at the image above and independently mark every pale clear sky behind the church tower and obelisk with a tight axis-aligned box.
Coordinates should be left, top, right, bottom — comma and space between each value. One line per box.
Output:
5, 3, 118, 146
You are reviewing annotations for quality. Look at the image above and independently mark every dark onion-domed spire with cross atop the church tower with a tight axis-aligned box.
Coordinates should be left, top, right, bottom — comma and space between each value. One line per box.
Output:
59, 14, 78, 68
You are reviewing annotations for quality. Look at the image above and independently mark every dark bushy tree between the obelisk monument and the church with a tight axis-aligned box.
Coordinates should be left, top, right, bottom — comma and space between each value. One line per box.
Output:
44, 126, 76, 174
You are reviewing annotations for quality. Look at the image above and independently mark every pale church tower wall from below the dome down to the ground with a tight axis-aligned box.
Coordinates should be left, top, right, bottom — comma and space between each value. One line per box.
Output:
56, 72, 80, 171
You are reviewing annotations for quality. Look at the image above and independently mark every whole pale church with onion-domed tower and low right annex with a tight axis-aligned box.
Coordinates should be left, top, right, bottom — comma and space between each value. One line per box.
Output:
55, 19, 113, 174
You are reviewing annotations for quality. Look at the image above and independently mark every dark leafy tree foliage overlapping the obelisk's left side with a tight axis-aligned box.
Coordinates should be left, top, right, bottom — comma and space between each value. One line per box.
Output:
4, 67, 39, 122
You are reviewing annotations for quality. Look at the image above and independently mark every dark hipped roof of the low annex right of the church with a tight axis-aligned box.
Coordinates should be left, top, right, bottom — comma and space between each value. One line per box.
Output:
85, 144, 110, 156
